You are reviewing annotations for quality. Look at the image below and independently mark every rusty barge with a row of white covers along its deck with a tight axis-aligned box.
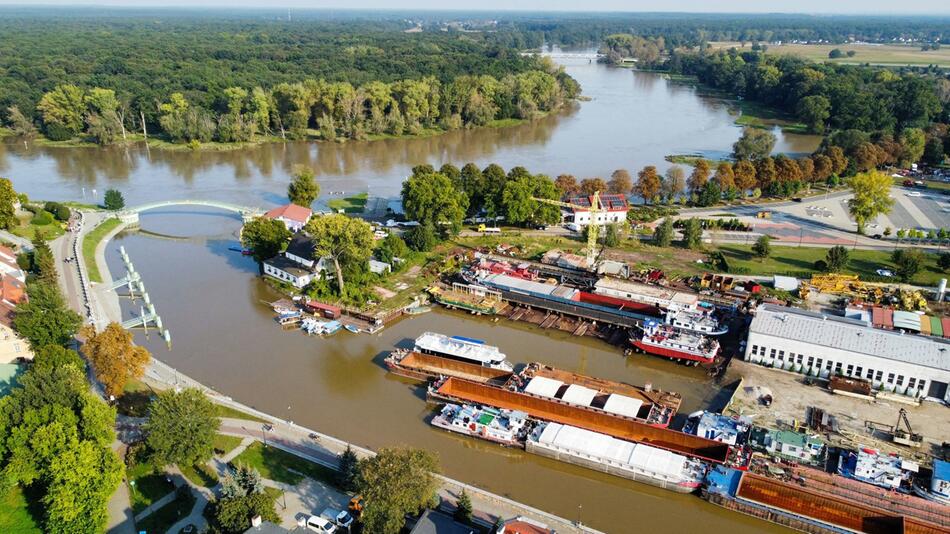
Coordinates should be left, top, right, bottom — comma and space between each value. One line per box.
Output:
505, 363, 683, 428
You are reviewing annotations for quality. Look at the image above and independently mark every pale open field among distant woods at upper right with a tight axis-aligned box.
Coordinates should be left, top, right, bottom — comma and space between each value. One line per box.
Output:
710, 42, 950, 67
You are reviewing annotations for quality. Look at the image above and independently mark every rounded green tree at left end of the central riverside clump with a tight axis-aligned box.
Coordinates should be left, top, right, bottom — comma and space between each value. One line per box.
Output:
402, 172, 470, 233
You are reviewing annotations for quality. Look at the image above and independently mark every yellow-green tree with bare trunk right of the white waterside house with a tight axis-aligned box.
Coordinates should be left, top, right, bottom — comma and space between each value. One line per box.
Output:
305, 215, 376, 296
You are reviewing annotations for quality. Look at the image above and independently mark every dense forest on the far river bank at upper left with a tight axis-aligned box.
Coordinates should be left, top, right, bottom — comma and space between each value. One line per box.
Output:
0, 10, 580, 144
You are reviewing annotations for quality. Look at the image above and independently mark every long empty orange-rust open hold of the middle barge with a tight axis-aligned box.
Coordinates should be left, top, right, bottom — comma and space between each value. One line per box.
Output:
430, 378, 729, 463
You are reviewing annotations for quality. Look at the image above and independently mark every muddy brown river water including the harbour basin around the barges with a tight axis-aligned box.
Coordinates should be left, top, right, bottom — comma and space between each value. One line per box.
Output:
0, 56, 816, 534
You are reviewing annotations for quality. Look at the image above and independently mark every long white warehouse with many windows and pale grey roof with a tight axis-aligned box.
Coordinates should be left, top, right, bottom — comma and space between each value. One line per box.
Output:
744, 304, 950, 402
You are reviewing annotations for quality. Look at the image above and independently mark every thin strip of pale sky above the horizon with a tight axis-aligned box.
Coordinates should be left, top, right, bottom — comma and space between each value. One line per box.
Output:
0, 0, 950, 15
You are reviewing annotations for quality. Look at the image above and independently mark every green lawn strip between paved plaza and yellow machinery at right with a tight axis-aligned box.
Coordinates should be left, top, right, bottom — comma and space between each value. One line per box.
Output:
719, 245, 946, 286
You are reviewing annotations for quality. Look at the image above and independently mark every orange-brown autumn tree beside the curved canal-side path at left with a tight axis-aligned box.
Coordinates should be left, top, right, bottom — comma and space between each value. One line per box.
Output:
81, 323, 152, 397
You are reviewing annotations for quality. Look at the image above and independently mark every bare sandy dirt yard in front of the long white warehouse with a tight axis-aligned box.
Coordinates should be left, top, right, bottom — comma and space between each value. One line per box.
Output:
726, 359, 950, 466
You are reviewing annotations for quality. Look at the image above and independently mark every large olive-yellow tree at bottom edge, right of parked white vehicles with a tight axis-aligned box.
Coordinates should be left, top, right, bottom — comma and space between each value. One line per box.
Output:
358, 448, 439, 534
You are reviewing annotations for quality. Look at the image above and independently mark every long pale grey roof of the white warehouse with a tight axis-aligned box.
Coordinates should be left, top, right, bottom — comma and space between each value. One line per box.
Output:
749, 304, 950, 371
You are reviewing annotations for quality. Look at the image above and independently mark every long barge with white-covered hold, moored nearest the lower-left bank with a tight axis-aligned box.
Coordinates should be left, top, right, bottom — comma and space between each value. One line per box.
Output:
525, 423, 706, 493
